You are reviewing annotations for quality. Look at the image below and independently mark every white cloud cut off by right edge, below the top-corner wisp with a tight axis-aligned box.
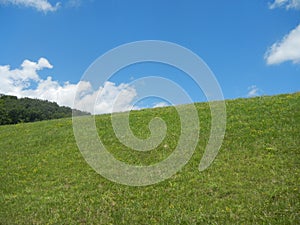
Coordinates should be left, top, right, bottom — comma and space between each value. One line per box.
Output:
265, 24, 300, 65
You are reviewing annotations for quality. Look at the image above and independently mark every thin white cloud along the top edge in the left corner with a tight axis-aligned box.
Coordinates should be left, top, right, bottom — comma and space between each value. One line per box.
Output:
0, 0, 60, 13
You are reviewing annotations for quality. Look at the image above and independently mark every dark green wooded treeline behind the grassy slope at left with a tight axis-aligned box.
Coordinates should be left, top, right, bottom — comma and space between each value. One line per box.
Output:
0, 94, 89, 125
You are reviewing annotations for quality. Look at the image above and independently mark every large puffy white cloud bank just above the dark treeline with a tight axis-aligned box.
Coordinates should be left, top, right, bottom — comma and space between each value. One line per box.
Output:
0, 58, 137, 114
